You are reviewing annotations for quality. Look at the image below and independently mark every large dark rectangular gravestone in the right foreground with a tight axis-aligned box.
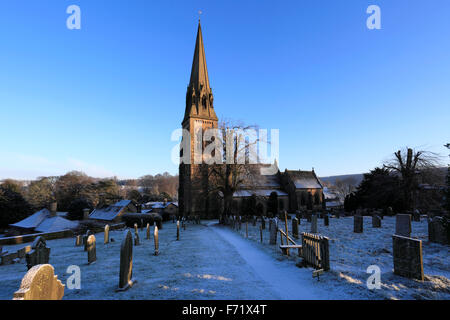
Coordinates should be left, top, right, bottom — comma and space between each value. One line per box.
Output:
392, 235, 424, 281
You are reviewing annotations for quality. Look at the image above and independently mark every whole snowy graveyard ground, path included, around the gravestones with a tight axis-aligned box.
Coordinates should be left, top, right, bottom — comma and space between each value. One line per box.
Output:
0, 216, 450, 300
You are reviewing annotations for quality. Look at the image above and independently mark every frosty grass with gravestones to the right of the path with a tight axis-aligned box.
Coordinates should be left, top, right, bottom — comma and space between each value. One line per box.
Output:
234, 217, 450, 300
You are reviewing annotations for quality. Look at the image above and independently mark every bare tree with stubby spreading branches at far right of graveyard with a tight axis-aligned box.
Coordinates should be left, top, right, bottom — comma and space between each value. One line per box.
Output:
384, 147, 439, 210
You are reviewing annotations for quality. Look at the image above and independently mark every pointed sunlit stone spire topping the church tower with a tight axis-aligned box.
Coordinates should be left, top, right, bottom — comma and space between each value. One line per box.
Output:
183, 19, 218, 123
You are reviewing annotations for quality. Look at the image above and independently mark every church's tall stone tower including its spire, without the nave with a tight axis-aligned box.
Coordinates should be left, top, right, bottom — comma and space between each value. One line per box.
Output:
178, 20, 218, 217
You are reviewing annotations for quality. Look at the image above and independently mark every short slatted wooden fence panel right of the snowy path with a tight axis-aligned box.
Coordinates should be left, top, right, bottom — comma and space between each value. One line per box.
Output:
302, 232, 330, 271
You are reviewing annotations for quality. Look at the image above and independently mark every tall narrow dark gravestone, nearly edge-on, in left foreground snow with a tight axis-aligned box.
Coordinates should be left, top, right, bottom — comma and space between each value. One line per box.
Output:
116, 230, 136, 291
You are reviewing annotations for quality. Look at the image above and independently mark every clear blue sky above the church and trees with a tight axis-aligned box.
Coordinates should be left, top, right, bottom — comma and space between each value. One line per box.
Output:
0, 0, 450, 179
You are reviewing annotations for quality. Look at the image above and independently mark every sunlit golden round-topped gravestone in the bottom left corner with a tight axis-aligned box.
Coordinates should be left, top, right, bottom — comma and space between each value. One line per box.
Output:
13, 264, 64, 300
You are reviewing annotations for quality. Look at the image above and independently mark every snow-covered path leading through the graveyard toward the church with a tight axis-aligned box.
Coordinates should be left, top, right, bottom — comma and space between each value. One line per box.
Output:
208, 222, 330, 300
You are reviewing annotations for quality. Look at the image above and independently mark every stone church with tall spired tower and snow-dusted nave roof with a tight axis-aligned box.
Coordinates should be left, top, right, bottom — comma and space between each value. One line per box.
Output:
178, 22, 324, 218
